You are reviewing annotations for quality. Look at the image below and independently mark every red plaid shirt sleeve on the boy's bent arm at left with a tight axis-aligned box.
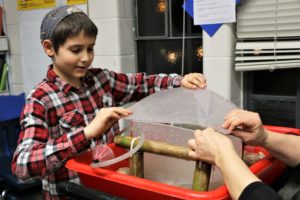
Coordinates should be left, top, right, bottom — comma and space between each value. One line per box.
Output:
12, 97, 89, 180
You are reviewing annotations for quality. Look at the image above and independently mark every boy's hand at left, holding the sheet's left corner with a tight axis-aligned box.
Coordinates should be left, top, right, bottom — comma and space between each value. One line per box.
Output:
84, 107, 132, 140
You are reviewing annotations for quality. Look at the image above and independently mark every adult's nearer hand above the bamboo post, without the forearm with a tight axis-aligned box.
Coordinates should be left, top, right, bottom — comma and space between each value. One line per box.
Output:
188, 128, 235, 165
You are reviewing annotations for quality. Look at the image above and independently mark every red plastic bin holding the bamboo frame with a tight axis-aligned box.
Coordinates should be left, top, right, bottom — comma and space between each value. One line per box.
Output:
66, 126, 300, 200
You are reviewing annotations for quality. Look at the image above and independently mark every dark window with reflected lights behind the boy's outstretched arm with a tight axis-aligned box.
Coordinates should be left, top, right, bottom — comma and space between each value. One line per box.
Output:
135, 0, 203, 74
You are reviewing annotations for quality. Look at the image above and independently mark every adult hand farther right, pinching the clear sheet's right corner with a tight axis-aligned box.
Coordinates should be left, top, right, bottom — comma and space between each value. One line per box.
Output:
223, 109, 268, 146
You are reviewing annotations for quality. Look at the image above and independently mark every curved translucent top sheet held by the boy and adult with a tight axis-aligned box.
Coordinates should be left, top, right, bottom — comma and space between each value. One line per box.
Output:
127, 88, 237, 133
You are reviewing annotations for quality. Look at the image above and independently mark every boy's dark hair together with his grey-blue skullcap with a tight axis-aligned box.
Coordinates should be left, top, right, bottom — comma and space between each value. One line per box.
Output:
40, 6, 98, 53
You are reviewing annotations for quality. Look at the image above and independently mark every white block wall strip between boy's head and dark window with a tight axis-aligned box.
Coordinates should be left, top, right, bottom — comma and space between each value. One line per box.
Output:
88, 0, 136, 73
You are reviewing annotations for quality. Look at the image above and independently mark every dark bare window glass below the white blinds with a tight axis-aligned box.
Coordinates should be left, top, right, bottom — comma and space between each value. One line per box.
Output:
244, 68, 300, 128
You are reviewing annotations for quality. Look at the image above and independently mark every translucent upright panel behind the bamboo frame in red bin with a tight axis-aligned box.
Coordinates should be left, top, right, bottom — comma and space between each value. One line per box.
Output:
130, 121, 242, 190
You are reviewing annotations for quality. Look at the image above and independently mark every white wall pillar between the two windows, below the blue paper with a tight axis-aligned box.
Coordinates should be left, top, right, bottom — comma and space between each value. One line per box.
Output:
203, 24, 242, 106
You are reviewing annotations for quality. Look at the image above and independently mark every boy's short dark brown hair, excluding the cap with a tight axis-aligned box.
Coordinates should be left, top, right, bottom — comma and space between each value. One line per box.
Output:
50, 13, 98, 53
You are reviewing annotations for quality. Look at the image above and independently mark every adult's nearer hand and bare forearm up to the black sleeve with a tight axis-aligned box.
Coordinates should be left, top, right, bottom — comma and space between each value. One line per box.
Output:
188, 128, 260, 199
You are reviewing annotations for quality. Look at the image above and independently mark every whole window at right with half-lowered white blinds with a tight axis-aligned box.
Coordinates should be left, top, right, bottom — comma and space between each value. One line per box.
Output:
235, 0, 300, 127
